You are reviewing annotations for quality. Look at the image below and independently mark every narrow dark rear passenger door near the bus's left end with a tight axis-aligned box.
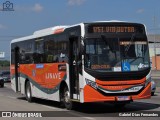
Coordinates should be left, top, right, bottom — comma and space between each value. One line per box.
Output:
15, 47, 21, 92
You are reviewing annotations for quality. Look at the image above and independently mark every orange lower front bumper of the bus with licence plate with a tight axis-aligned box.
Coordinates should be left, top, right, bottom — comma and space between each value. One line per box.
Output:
84, 83, 151, 102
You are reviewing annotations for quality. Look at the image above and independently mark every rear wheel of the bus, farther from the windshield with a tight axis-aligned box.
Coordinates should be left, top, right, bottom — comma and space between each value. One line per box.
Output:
25, 81, 33, 102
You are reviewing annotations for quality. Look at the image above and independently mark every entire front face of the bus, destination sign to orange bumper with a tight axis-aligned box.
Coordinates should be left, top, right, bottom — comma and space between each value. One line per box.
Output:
83, 22, 151, 103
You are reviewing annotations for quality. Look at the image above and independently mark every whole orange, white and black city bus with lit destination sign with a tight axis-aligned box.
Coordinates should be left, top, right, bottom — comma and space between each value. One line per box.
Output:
10, 21, 151, 109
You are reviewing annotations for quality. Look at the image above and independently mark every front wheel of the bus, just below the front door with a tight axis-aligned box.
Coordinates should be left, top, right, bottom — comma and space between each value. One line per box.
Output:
63, 87, 73, 110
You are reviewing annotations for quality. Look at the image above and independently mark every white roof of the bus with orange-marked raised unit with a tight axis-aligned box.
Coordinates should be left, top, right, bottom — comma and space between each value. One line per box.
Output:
11, 20, 144, 43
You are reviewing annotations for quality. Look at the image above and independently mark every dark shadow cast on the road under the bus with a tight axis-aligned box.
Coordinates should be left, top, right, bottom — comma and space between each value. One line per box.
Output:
18, 96, 160, 117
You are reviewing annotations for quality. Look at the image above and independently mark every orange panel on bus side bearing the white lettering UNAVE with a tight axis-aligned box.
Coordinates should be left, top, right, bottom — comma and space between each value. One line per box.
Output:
11, 63, 66, 88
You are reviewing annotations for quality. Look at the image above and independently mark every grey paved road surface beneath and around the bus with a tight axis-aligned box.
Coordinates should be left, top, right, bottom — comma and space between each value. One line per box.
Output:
0, 83, 160, 120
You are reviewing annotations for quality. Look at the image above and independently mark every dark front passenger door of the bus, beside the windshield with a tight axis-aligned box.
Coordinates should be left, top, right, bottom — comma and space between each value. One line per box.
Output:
69, 37, 79, 100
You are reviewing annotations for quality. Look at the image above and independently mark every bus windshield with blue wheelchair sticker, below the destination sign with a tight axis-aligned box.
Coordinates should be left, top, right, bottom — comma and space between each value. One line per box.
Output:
85, 35, 150, 72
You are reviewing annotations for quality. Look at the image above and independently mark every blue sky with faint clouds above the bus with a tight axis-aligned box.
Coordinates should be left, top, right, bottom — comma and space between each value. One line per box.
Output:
0, 0, 160, 60
